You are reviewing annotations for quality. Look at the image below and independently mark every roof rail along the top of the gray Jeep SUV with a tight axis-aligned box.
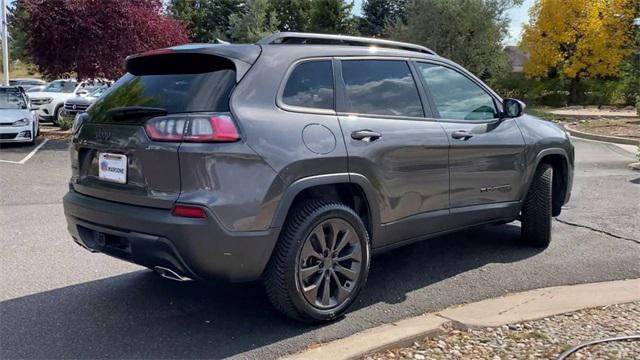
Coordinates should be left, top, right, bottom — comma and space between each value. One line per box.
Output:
257, 32, 437, 55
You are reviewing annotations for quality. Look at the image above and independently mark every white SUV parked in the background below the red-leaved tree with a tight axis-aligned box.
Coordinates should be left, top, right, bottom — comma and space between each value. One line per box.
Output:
28, 79, 100, 124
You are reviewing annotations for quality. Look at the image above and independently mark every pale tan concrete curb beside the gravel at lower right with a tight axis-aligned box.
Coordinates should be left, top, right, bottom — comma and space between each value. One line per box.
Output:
284, 279, 640, 360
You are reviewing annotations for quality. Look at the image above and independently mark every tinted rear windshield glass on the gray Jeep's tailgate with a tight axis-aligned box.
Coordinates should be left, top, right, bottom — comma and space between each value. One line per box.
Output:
89, 69, 236, 122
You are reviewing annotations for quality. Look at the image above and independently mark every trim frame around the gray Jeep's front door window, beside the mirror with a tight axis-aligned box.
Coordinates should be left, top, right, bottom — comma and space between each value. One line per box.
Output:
412, 58, 502, 124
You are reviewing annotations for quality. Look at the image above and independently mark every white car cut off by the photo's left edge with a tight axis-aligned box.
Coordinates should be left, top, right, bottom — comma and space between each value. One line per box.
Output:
0, 86, 40, 144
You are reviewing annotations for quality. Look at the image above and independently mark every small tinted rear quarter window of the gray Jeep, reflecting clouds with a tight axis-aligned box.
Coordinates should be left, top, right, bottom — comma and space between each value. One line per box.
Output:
282, 60, 333, 109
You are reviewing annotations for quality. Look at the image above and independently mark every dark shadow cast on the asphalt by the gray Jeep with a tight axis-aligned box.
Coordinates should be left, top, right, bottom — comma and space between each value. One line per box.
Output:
0, 225, 541, 358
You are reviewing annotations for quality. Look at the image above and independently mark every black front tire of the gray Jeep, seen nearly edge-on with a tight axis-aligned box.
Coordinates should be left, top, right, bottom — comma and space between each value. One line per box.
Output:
521, 164, 553, 247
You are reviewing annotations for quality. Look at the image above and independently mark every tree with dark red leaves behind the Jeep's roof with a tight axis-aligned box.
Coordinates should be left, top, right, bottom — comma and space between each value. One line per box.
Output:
18, 0, 189, 79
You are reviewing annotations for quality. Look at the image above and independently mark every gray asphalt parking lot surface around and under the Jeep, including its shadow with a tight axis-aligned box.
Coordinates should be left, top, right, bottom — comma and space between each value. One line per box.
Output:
0, 136, 640, 359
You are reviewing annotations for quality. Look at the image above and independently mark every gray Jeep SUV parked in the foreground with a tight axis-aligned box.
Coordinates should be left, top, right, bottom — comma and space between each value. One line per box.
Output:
64, 33, 574, 322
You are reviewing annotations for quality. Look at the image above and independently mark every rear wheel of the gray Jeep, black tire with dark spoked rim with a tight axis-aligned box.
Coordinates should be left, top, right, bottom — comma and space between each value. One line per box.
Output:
264, 200, 370, 323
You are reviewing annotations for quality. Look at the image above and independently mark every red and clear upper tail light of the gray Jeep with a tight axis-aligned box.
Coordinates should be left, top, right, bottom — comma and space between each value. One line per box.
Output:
144, 114, 240, 142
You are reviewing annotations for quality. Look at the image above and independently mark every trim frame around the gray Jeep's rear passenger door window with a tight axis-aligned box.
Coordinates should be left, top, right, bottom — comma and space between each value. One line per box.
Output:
333, 56, 436, 121
